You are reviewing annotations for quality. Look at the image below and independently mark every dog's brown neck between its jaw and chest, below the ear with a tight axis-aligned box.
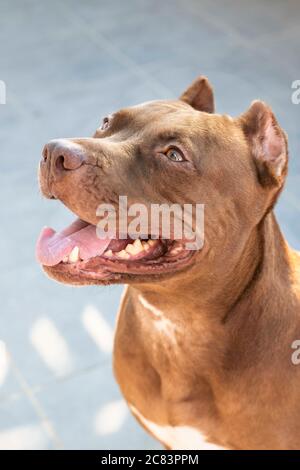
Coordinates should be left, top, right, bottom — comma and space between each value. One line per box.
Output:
132, 212, 290, 322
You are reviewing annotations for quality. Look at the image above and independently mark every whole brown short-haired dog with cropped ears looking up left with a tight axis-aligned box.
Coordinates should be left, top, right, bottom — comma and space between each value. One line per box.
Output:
37, 77, 300, 449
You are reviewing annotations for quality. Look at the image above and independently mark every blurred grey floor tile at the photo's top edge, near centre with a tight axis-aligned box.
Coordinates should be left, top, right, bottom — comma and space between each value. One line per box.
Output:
67, 1, 237, 66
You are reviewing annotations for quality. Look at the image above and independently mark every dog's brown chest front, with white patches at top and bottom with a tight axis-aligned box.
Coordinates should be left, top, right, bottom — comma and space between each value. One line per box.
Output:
115, 296, 225, 449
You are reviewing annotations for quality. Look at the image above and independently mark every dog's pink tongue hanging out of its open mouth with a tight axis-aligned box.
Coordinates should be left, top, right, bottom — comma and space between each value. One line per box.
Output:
36, 219, 110, 266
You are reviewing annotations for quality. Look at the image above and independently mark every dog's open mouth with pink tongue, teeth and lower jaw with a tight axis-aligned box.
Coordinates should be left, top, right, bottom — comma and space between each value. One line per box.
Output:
36, 219, 195, 284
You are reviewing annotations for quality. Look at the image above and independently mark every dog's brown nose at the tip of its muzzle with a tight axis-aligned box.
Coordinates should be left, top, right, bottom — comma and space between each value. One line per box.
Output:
42, 139, 85, 175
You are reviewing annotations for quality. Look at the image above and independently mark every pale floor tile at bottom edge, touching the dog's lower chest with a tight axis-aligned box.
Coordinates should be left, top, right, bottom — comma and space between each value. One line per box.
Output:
37, 365, 161, 450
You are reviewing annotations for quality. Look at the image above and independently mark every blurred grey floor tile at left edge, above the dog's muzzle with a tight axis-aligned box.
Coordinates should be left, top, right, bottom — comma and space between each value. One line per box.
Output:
2, 31, 126, 114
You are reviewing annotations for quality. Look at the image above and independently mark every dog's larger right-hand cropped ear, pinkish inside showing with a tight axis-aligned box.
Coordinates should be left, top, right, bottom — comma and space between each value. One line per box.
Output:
239, 101, 288, 187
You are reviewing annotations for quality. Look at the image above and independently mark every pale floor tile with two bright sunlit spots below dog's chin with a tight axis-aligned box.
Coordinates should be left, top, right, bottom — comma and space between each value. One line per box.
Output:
0, 255, 122, 387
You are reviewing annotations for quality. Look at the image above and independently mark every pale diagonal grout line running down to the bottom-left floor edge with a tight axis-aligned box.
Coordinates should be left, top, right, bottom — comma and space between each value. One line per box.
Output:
8, 353, 64, 449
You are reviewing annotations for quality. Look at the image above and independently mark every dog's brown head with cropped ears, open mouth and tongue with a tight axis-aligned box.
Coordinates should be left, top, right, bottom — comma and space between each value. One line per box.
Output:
37, 77, 288, 284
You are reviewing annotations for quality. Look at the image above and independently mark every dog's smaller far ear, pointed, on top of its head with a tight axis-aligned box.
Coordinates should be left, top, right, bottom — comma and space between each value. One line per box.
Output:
180, 76, 215, 113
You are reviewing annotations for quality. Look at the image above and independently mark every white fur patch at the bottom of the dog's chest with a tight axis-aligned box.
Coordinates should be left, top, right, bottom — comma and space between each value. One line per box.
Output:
129, 405, 225, 450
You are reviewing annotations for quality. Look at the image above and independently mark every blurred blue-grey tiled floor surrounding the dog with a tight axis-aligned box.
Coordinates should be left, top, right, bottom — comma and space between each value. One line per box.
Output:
0, 0, 300, 449
